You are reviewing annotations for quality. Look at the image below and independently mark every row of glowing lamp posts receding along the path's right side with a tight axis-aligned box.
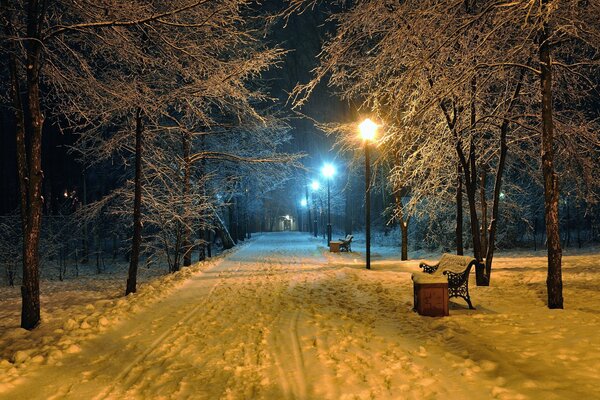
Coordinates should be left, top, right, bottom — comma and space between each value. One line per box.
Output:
301, 118, 379, 269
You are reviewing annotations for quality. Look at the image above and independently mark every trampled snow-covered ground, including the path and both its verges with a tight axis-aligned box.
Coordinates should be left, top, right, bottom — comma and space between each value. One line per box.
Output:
0, 233, 600, 399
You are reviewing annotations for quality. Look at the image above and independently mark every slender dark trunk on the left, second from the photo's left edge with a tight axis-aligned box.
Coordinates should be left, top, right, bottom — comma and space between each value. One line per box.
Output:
125, 107, 144, 295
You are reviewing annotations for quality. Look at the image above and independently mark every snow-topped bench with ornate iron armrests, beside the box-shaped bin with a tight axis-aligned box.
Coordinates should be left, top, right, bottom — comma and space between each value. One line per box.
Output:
413, 253, 477, 309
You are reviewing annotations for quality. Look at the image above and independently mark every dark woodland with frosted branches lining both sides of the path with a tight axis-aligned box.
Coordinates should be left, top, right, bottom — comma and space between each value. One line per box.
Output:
0, 0, 600, 329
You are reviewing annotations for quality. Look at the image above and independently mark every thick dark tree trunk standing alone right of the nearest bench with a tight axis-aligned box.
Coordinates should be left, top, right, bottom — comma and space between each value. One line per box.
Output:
539, 0, 563, 309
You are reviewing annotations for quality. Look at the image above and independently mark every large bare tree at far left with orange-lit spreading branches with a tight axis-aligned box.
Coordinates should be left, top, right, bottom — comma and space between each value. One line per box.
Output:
1, 0, 296, 329
